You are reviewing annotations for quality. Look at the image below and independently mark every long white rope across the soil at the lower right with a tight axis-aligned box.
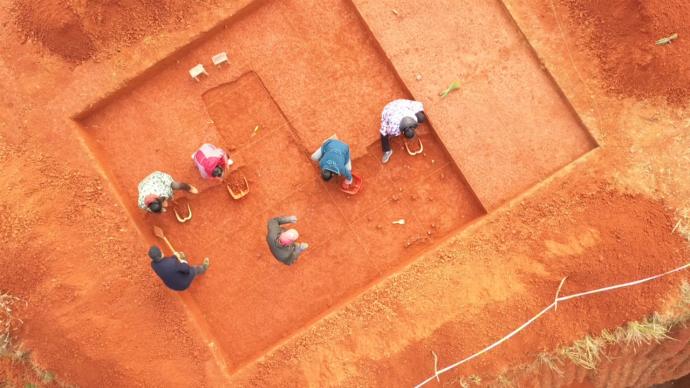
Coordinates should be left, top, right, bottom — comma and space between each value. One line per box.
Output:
415, 263, 690, 388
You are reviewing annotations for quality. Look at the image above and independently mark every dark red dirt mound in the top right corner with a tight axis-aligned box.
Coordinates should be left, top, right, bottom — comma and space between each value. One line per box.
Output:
563, 0, 690, 105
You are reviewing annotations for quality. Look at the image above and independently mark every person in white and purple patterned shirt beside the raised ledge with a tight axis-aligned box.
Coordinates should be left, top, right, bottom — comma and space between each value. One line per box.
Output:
379, 99, 426, 163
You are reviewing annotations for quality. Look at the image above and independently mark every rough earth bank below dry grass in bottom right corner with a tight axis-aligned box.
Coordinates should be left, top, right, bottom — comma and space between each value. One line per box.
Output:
495, 327, 690, 388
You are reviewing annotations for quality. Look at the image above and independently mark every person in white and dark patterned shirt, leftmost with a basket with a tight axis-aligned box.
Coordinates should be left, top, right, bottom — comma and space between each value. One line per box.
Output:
139, 171, 199, 213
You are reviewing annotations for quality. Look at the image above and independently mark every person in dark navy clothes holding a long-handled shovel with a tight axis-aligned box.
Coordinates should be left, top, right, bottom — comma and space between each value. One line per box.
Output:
149, 245, 210, 291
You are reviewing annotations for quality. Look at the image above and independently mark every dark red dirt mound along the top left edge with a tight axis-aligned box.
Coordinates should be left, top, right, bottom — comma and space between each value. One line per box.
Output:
14, 0, 199, 63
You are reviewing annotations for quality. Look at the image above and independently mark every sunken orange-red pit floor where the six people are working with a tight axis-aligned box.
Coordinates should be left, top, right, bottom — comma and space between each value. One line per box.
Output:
80, 2, 484, 368
